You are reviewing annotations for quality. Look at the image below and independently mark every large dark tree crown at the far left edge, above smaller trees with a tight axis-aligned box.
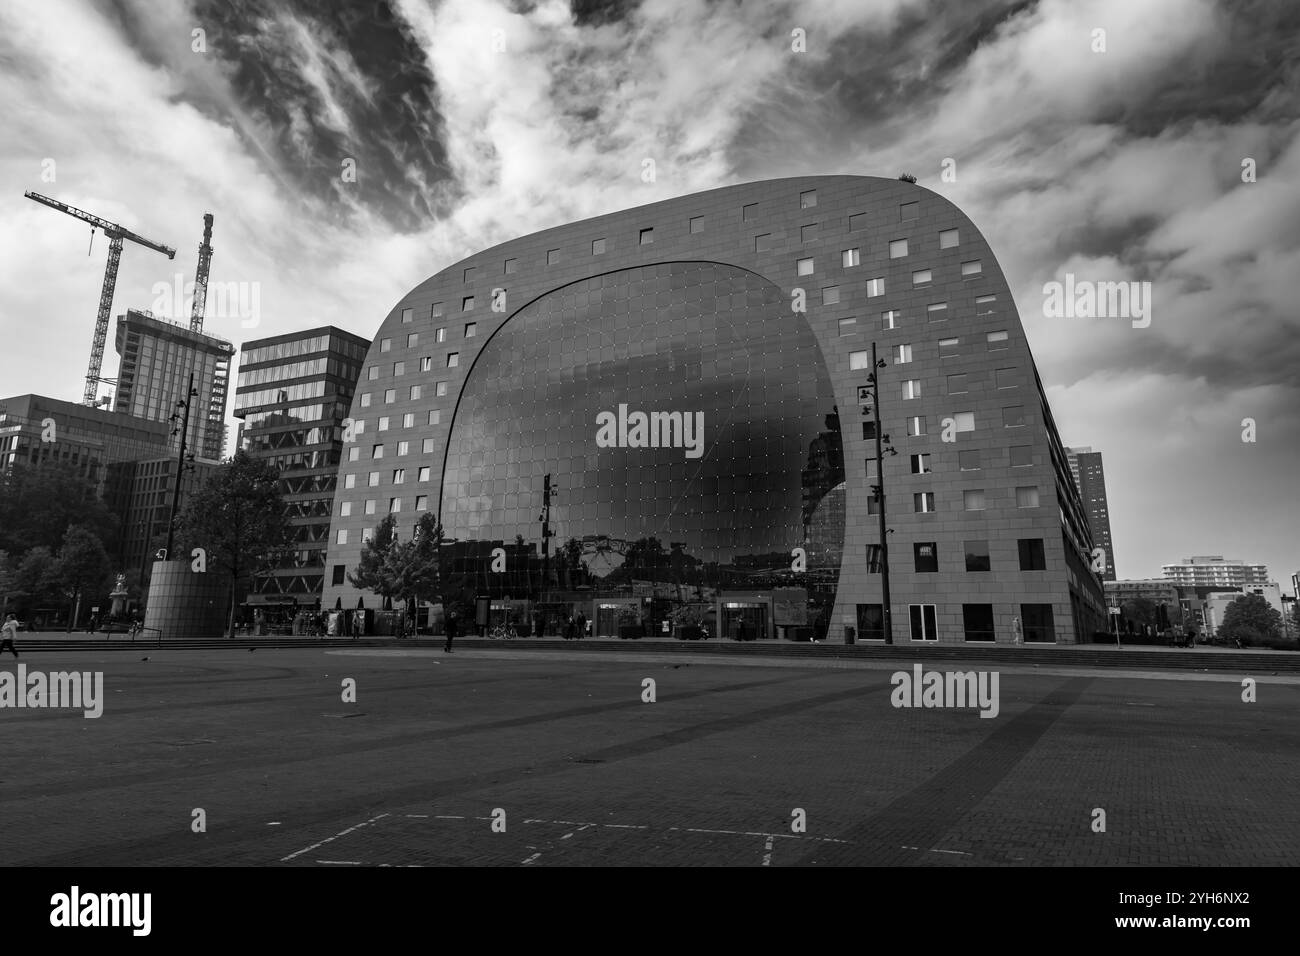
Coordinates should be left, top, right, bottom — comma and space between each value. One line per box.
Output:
0, 460, 118, 557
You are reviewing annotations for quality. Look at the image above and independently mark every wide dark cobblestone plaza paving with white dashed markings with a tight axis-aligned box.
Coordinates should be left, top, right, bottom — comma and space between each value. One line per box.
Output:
0, 648, 1300, 868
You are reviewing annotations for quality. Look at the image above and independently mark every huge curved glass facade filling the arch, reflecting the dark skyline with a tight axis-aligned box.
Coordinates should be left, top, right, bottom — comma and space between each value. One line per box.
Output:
441, 263, 844, 637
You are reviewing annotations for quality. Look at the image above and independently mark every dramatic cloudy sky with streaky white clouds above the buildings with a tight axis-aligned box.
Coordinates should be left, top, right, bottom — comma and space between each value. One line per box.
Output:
0, 0, 1300, 591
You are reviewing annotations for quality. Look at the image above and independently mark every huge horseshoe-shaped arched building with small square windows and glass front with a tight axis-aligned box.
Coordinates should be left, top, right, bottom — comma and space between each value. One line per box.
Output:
324, 176, 1106, 644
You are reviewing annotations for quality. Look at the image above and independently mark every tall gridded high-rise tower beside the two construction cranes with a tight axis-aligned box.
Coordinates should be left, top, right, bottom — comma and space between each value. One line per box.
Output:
113, 308, 235, 462
